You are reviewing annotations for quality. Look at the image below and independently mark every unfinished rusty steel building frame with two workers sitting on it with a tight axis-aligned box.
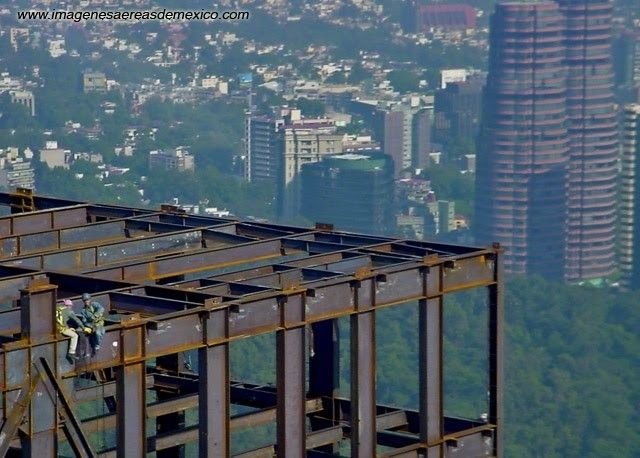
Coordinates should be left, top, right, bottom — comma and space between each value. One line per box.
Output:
0, 191, 503, 458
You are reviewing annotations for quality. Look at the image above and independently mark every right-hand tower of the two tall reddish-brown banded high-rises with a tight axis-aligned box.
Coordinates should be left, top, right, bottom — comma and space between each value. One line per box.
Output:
558, 0, 618, 280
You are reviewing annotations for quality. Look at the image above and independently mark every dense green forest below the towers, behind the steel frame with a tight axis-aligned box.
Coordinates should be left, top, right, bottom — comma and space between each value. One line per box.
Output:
378, 277, 640, 458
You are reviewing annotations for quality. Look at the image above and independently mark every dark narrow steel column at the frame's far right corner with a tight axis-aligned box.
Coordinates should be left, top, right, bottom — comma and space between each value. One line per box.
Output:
488, 244, 504, 458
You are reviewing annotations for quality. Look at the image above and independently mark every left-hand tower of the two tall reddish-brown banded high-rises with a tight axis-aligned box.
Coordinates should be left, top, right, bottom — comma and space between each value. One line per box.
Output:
474, 2, 569, 279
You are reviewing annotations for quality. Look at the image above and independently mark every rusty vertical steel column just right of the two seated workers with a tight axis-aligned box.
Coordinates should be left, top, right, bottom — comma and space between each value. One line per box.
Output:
116, 326, 147, 458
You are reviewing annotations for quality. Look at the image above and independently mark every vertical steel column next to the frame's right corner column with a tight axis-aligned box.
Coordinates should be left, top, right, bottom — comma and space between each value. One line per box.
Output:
418, 265, 444, 458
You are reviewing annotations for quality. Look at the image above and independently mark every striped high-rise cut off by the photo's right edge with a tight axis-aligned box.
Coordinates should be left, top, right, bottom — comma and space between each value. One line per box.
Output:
618, 104, 640, 290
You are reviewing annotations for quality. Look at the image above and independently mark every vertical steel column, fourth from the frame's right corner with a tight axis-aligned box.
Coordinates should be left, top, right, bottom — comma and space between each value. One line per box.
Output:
276, 294, 306, 458
